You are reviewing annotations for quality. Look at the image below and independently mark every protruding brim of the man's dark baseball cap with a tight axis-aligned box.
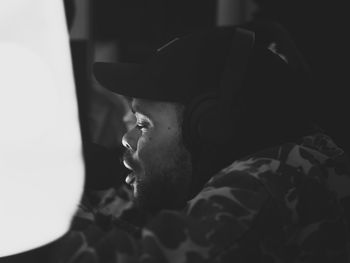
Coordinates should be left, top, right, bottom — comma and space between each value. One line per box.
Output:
93, 62, 154, 99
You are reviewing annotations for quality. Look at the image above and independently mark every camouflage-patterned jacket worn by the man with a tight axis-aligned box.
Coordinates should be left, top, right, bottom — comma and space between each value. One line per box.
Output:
52, 134, 350, 263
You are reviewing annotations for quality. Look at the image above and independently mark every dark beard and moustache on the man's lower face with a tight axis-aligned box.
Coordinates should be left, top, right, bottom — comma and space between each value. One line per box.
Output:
124, 136, 192, 214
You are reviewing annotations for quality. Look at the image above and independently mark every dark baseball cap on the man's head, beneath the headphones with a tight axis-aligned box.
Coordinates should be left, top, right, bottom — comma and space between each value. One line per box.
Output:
93, 20, 308, 104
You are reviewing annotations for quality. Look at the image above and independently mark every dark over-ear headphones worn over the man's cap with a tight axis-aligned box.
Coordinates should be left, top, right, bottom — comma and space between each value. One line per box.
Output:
183, 27, 255, 149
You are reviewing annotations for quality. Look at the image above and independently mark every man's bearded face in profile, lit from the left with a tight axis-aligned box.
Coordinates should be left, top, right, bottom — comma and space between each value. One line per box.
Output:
123, 99, 192, 212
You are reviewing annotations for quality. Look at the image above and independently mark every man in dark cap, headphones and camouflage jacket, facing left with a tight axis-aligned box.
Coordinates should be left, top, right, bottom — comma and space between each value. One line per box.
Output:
53, 21, 350, 262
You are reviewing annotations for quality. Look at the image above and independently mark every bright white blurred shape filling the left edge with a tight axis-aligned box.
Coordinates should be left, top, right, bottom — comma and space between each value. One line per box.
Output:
0, 0, 84, 257
